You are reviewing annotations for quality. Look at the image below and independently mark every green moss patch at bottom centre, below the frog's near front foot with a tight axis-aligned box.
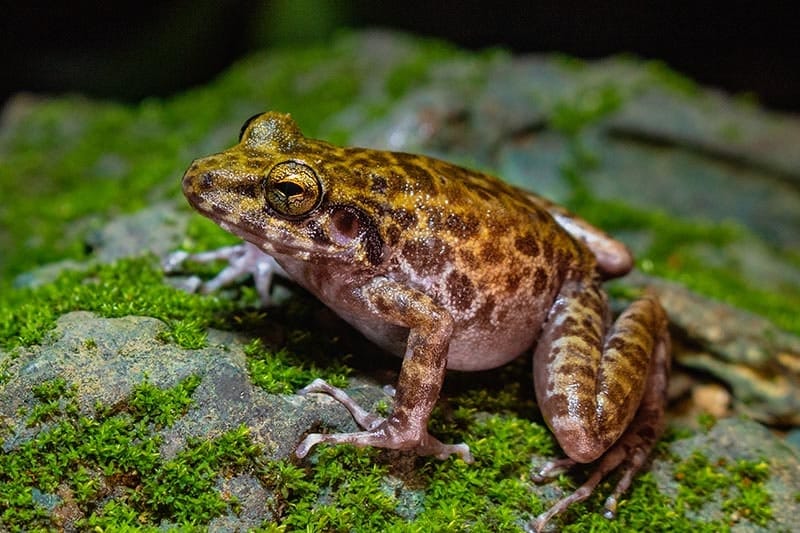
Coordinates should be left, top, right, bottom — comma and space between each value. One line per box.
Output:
261, 417, 552, 531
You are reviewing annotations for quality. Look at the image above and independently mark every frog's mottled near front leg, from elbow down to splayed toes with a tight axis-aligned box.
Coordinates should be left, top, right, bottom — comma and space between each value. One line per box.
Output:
295, 278, 472, 462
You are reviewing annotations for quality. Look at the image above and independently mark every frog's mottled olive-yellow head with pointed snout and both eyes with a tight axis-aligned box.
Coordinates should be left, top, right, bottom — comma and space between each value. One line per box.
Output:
183, 112, 383, 266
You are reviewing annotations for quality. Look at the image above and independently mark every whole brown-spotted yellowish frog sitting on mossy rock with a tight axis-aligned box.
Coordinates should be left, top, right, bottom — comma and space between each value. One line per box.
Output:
168, 112, 670, 531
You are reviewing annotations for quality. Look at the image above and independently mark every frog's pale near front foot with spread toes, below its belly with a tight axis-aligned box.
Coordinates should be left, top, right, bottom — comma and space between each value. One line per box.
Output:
295, 379, 474, 463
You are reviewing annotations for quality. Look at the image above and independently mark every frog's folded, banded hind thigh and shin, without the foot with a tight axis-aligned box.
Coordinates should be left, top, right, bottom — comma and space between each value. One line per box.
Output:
534, 281, 666, 463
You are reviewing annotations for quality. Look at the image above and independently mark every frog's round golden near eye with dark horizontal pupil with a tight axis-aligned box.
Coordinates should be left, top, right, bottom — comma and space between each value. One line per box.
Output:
264, 161, 322, 217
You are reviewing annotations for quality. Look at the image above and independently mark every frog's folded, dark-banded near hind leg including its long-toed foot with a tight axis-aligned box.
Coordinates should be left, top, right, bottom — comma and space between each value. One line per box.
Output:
531, 280, 670, 531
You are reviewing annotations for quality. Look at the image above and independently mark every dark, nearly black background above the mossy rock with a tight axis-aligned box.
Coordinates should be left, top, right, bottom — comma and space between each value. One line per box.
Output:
0, 0, 800, 112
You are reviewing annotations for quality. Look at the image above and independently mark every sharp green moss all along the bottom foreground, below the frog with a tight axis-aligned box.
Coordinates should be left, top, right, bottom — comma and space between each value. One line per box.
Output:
0, 364, 770, 532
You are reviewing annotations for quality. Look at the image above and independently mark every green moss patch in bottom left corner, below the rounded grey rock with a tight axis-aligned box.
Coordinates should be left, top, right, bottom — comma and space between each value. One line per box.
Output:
0, 376, 260, 531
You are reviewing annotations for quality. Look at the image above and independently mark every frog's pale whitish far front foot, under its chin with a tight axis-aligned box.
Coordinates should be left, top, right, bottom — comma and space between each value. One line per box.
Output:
162, 242, 286, 305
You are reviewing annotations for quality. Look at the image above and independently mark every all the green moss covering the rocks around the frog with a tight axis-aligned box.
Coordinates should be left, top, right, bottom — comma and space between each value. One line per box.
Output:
0, 32, 788, 531
